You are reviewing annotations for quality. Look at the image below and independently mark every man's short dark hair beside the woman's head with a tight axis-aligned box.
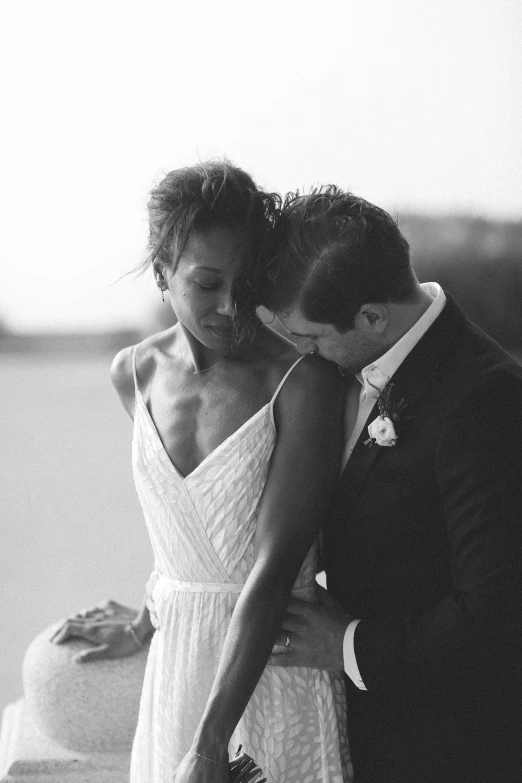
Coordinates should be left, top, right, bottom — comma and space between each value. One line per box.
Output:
263, 185, 416, 331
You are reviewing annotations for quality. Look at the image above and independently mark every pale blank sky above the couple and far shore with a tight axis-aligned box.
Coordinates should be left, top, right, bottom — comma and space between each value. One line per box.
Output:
0, 0, 522, 331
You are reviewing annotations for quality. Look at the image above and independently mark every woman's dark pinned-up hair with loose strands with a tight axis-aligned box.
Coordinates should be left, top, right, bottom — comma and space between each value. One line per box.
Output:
143, 160, 280, 346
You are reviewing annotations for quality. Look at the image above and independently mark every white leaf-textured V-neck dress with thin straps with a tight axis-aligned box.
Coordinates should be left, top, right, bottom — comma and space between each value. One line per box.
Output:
131, 356, 352, 783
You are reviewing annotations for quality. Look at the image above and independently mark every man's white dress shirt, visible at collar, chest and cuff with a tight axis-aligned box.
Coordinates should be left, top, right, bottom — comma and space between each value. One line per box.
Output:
341, 283, 446, 690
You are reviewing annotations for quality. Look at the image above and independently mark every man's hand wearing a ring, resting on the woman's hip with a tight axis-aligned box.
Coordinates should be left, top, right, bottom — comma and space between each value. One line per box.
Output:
268, 585, 353, 671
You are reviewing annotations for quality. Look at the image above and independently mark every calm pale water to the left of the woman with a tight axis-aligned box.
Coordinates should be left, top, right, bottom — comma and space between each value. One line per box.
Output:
0, 355, 152, 710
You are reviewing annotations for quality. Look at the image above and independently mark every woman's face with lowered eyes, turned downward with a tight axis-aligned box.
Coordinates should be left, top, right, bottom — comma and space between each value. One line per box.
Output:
161, 228, 248, 350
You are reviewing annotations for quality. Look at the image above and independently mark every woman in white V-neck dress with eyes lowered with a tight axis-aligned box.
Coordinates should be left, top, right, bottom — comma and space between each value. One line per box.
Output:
51, 161, 351, 783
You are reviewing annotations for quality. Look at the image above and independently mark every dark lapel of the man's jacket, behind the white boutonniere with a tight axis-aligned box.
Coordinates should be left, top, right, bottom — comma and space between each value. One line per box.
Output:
340, 294, 466, 500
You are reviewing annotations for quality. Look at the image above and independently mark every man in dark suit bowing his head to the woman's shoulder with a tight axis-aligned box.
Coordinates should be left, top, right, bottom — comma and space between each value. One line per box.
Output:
268, 186, 522, 783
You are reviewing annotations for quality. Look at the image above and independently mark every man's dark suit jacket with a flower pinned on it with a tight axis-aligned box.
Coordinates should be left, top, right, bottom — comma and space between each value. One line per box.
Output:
325, 297, 522, 783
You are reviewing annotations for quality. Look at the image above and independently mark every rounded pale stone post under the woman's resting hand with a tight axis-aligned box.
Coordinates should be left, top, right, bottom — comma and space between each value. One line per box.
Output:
0, 624, 147, 783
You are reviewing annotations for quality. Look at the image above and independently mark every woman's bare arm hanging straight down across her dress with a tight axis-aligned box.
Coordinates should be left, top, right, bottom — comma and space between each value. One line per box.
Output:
176, 357, 343, 783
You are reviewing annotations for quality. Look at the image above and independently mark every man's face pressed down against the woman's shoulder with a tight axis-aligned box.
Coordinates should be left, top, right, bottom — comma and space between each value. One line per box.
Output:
277, 308, 383, 374
